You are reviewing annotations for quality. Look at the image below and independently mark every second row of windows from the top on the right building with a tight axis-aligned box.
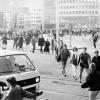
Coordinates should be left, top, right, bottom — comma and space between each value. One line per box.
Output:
60, 5, 98, 9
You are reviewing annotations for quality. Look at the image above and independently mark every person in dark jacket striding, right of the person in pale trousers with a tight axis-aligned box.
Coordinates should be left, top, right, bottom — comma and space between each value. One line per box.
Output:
78, 48, 91, 83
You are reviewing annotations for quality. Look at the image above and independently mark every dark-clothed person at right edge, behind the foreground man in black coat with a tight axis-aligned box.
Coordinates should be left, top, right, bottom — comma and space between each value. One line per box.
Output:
92, 50, 100, 72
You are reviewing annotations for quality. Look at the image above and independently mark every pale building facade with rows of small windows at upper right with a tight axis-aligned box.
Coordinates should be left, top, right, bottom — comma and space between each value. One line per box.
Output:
57, 0, 100, 28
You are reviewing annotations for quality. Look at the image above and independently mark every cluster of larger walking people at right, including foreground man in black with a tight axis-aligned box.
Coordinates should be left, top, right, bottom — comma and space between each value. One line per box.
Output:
55, 40, 100, 100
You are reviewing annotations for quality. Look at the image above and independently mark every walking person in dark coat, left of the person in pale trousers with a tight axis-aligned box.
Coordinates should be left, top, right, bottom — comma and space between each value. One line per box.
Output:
60, 44, 71, 77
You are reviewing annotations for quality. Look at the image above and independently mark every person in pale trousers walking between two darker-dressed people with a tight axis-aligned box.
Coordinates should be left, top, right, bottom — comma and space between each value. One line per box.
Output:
71, 47, 78, 80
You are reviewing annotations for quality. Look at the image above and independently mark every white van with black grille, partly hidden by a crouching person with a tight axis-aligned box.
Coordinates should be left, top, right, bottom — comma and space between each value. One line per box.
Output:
0, 50, 40, 100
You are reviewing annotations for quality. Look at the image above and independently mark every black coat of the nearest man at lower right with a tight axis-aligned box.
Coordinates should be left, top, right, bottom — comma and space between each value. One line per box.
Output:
81, 71, 100, 91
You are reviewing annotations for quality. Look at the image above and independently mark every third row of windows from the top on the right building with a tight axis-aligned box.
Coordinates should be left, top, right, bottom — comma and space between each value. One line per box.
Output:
60, 11, 98, 15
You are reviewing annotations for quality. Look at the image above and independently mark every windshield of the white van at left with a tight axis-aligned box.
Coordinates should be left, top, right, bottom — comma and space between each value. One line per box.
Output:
0, 55, 35, 74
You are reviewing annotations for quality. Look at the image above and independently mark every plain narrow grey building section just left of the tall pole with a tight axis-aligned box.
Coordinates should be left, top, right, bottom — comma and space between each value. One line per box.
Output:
44, 0, 56, 29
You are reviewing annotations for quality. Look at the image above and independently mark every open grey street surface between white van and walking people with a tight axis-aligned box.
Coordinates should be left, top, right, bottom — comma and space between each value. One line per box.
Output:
1, 34, 100, 100
